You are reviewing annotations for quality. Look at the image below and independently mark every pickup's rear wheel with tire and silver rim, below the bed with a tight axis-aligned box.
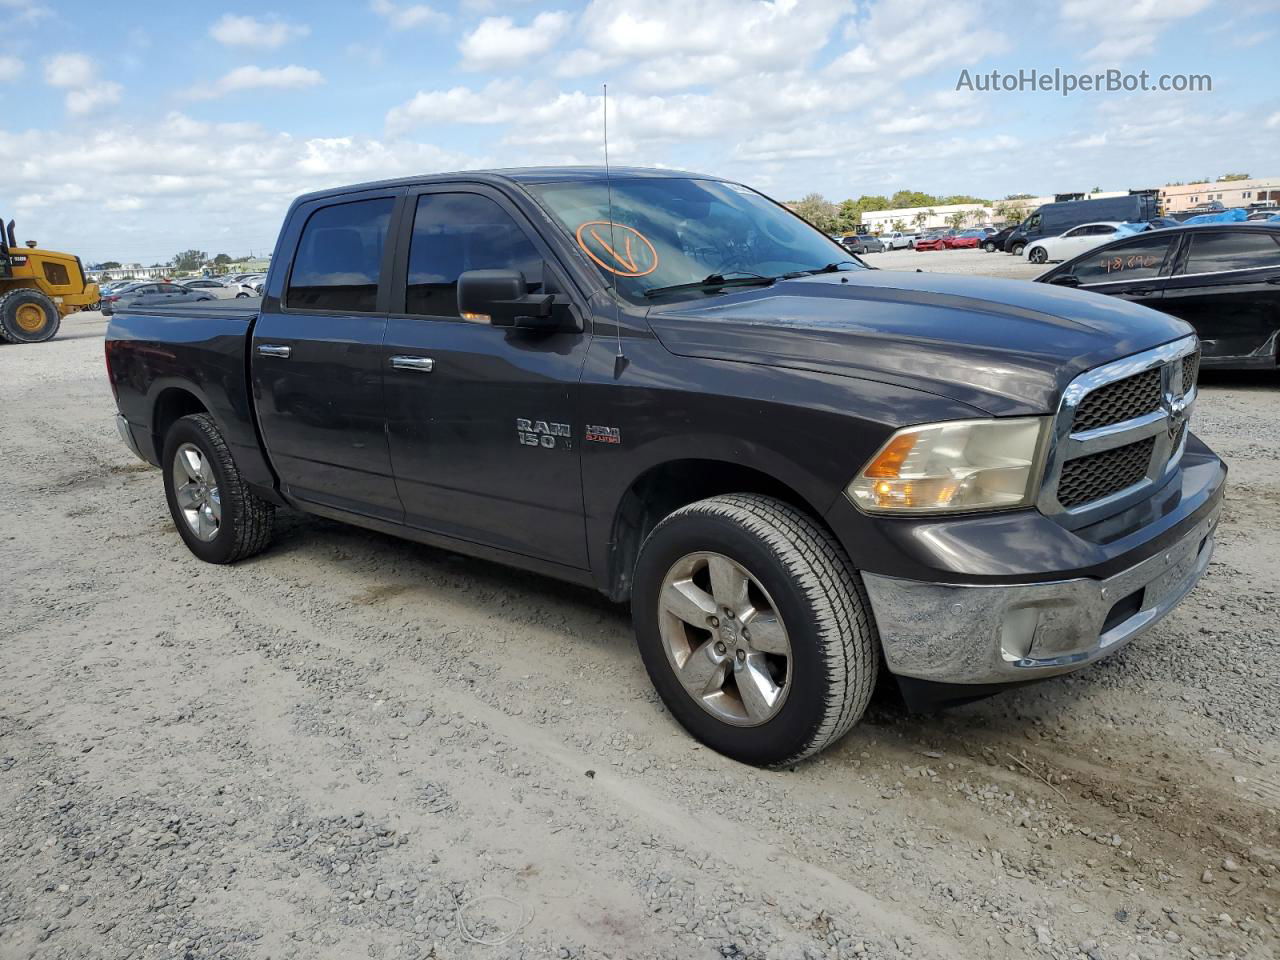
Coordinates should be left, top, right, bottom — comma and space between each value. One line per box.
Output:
160, 413, 275, 563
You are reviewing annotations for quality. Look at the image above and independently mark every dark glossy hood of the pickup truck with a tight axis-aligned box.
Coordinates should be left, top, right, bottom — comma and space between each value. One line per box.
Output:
649, 270, 1192, 416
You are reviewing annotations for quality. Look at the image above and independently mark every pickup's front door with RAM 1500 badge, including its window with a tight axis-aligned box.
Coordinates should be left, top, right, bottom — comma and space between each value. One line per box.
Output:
383, 184, 589, 567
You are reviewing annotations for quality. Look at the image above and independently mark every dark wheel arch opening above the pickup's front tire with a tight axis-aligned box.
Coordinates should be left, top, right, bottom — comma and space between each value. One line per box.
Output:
604, 457, 827, 603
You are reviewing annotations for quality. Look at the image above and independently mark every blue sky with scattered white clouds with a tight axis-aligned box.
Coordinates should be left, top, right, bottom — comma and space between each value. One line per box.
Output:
0, 0, 1280, 265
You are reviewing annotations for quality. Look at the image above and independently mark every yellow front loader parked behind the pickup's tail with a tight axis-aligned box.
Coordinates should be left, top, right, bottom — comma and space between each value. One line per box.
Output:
0, 220, 100, 343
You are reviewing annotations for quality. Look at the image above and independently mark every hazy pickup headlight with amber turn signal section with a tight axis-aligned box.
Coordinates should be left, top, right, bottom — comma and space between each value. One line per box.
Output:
849, 417, 1051, 513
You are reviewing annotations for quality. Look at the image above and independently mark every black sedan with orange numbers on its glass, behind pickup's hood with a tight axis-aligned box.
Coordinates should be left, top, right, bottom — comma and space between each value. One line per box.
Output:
1036, 221, 1280, 370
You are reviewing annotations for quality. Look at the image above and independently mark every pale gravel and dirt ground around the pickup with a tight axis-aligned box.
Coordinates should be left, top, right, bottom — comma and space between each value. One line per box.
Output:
0, 302, 1280, 960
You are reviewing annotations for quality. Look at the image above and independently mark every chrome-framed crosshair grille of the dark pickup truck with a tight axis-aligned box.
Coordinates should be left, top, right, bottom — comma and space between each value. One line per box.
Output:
1037, 337, 1199, 527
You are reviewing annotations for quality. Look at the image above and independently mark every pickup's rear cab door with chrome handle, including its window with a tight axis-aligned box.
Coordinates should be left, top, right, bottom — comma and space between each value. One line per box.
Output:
250, 188, 403, 521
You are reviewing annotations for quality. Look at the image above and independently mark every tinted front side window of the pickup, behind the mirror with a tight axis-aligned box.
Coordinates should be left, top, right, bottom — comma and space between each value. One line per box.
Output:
404, 193, 543, 317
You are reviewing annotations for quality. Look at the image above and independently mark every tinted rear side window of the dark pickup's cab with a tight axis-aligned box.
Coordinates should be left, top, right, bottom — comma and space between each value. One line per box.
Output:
284, 197, 396, 314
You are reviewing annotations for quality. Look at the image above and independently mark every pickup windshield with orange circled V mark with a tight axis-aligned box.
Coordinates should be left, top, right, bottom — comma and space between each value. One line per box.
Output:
526, 177, 865, 303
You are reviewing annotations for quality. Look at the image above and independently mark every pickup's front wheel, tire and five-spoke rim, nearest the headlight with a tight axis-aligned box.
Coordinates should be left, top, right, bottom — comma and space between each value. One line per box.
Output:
631, 494, 879, 767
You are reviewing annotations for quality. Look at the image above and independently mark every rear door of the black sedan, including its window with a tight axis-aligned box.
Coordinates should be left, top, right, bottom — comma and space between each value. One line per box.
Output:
1161, 227, 1280, 365
